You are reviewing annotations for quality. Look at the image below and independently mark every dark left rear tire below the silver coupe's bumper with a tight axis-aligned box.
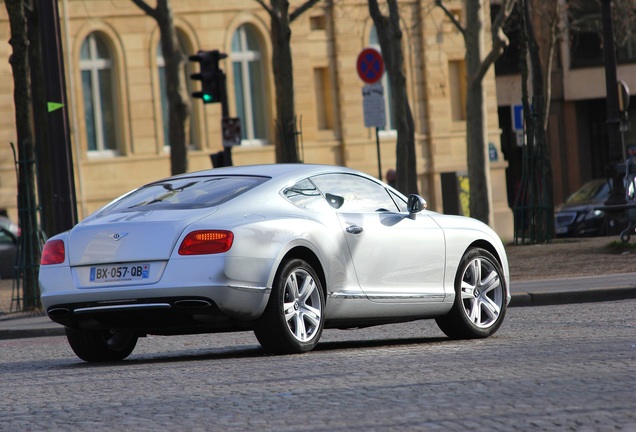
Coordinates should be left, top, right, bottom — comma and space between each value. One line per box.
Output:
66, 327, 138, 362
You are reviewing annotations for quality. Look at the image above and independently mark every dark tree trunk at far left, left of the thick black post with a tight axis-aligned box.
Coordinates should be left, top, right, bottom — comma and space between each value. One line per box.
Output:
5, 0, 41, 310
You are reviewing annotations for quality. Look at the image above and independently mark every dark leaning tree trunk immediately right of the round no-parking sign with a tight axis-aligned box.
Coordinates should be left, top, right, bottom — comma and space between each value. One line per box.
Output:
369, 0, 417, 194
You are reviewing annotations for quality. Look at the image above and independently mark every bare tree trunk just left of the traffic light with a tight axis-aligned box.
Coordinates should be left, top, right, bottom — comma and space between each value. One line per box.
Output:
132, 0, 190, 175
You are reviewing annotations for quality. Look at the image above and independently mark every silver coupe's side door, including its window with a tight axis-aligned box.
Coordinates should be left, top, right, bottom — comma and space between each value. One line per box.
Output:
312, 174, 445, 302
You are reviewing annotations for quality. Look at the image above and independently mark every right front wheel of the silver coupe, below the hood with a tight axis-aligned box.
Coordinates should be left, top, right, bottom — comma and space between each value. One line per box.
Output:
435, 248, 506, 339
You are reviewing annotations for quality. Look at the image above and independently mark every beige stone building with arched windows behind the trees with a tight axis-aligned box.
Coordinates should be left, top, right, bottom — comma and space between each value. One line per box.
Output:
0, 0, 512, 239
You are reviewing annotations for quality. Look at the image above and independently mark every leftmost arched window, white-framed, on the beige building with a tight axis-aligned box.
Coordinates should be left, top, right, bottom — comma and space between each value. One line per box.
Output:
80, 33, 117, 154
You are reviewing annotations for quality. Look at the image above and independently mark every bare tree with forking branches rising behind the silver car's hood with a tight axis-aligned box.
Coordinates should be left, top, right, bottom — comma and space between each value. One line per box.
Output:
435, 0, 516, 223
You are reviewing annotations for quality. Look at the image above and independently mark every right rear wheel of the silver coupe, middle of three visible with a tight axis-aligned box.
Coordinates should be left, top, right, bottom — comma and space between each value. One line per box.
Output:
254, 259, 325, 354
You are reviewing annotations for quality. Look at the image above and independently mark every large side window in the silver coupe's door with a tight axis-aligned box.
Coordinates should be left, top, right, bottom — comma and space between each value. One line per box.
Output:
311, 173, 398, 213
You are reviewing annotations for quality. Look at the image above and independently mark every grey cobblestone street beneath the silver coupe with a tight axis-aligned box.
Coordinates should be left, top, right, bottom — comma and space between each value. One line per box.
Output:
0, 300, 636, 432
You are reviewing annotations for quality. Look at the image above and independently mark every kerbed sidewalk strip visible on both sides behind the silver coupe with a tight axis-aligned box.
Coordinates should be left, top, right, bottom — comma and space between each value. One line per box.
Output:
0, 273, 636, 340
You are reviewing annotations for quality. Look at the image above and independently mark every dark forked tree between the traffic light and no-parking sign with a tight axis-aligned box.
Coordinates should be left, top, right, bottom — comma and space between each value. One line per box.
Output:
254, 0, 320, 163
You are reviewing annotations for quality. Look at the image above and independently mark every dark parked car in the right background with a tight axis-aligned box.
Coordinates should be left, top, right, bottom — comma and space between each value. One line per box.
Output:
554, 179, 634, 237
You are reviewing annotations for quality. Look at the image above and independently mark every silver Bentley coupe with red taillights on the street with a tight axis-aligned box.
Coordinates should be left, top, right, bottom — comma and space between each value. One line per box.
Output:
40, 164, 510, 361
